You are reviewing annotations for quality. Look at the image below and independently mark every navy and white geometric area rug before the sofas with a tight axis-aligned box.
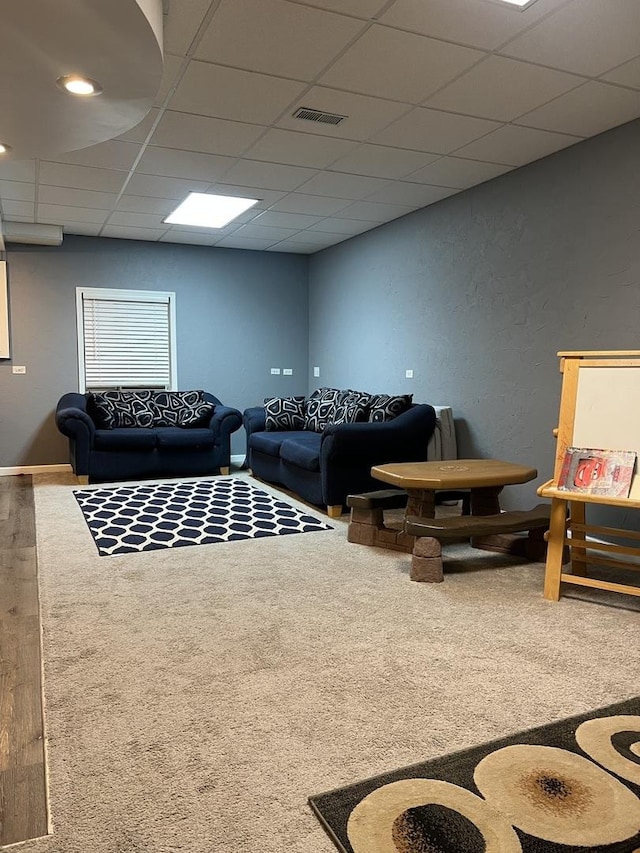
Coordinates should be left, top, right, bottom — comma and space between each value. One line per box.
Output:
74, 478, 333, 557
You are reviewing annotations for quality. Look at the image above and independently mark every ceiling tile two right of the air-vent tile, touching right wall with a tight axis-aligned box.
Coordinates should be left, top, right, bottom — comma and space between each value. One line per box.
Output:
456, 124, 581, 166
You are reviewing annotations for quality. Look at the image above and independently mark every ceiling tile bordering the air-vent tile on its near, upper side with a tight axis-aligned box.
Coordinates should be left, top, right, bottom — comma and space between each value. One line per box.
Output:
320, 25, 485, 104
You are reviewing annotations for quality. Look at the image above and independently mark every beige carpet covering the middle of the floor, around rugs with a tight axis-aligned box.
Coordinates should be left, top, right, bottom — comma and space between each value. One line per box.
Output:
21, 475, 640, 853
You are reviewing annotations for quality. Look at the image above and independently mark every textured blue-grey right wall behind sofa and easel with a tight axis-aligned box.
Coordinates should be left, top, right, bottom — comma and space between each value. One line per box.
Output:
309, 116, 640, 505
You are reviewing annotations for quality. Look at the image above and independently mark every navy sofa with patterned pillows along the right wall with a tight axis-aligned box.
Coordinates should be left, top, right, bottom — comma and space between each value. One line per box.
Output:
243, 389, 436, 517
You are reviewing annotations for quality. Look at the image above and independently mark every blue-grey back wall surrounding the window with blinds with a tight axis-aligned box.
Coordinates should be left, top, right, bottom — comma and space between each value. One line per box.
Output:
0, 237, 308, 467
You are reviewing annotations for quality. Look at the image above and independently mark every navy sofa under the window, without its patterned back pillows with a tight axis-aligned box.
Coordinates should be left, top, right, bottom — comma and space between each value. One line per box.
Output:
55, 392, 242, 483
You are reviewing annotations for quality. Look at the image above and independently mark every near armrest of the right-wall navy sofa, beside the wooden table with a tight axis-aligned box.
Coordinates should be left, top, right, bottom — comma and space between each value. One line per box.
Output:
321, 403, 436, 466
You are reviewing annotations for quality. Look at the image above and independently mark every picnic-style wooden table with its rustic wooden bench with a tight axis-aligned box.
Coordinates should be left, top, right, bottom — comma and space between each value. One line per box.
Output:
360, 459, 549, 581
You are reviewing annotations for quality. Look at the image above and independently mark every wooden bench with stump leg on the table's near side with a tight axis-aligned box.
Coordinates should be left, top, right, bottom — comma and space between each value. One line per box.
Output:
404, 504, 551, 583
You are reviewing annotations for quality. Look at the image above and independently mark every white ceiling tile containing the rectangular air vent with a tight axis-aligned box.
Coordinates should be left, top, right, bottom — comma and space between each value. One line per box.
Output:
278, 86, 409, 140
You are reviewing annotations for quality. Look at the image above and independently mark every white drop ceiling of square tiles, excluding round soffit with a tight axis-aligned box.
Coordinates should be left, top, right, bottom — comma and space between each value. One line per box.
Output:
0, 0, 640, 253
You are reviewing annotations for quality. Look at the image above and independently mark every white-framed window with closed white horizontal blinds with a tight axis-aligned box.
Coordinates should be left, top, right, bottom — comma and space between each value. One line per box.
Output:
76, 287, 177, 392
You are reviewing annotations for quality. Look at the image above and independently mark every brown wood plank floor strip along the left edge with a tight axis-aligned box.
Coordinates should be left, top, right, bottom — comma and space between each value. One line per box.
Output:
0, 477, 47, 847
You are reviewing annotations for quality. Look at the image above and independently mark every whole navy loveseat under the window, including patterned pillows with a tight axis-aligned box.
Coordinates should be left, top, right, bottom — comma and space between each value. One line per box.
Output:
56, 391, 242, 483
